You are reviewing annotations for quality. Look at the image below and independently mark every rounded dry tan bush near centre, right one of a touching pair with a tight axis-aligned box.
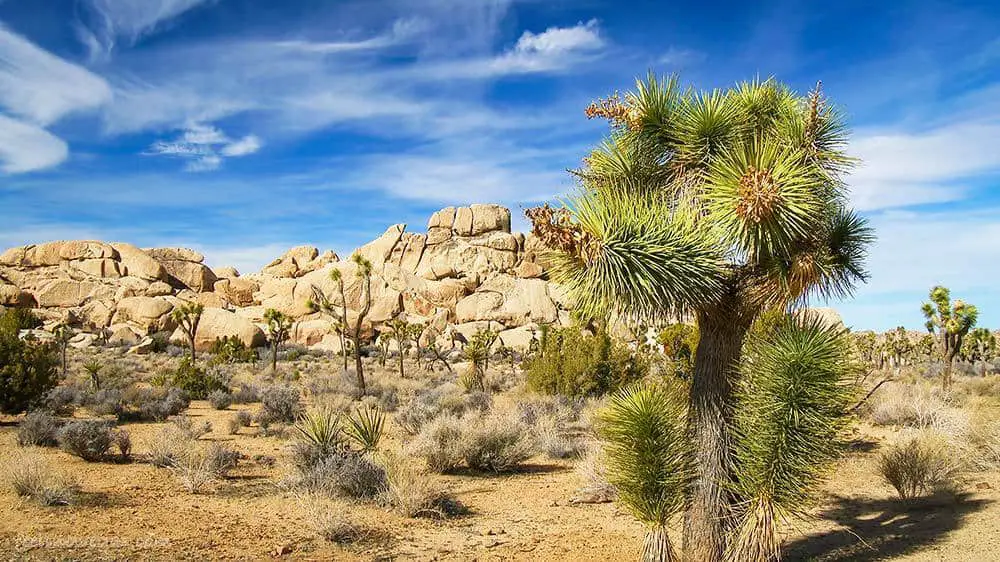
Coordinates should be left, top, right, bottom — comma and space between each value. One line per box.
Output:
464, 411, 537, 472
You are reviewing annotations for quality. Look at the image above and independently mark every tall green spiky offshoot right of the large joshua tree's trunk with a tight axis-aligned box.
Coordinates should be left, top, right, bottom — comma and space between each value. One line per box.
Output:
727, 317, 854, 562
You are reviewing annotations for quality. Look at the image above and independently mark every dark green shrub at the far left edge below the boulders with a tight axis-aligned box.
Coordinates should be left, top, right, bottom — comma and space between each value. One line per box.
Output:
0, 308, 59, 414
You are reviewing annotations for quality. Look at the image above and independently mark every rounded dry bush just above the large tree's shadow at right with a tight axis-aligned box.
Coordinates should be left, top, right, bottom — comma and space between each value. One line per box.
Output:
878, 433, 957, 499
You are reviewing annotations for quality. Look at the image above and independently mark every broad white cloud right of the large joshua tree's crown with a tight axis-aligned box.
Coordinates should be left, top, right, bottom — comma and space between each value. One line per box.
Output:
850, 119, 1000, 211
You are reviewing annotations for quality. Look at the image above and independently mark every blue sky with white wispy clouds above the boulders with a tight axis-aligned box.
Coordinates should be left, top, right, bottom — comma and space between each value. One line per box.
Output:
0, 0, 1000, 329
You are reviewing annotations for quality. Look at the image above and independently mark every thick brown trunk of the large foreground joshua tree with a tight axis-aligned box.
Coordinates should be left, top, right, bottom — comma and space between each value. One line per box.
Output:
684, 297, 750, 562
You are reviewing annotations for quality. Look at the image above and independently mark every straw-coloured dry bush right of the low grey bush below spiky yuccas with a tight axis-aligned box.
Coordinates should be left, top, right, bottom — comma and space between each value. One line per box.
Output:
378, 452, 461, 518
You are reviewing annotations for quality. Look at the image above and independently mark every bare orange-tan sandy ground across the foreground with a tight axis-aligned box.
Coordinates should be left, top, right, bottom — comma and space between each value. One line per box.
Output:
0, 356, 1000, 562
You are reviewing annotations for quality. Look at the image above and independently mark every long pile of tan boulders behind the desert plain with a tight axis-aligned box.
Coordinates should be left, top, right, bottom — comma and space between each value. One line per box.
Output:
0, 205, 571, 351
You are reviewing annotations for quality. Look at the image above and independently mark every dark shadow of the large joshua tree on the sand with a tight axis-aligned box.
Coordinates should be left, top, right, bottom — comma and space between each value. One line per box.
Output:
783, 494, 993, 562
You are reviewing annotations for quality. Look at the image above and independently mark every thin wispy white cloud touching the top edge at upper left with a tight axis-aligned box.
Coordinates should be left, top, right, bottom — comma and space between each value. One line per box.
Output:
77, 0, 215, 58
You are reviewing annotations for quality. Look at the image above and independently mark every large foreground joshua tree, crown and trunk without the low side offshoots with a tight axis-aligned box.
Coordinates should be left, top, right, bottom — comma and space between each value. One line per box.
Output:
528, 75, 873, 562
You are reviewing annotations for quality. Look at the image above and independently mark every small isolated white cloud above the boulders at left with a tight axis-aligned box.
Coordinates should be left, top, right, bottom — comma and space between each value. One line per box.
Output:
144, 123, 261, 172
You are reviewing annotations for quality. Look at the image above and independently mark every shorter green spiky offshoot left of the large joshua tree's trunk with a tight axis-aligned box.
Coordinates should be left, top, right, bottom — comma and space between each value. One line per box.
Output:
598, 383, 691, 562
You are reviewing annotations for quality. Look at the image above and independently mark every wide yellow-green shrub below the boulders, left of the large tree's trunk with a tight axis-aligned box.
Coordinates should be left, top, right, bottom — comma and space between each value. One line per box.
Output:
525, 326, 649, 396
